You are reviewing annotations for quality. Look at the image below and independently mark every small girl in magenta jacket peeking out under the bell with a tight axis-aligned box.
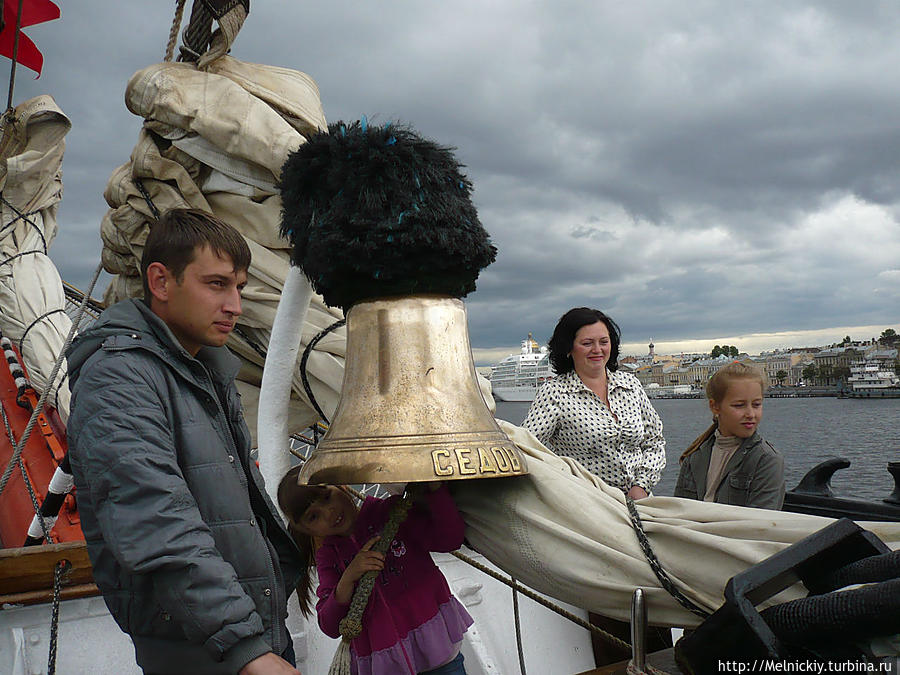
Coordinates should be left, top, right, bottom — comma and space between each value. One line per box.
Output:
278, 467, 472, 675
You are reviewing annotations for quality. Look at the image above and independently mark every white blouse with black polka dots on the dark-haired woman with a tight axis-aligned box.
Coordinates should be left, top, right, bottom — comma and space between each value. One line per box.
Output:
522, 370, 666, 492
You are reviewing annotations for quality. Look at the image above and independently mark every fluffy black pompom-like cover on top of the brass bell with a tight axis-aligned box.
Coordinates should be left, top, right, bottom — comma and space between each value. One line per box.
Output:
281, 120, 497, 311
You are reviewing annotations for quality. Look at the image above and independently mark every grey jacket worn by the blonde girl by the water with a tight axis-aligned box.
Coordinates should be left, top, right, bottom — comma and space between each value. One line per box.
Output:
674, 431, 784, 511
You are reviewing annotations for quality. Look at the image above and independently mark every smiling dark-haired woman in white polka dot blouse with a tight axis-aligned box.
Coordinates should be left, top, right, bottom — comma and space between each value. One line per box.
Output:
523, 307, 666, 499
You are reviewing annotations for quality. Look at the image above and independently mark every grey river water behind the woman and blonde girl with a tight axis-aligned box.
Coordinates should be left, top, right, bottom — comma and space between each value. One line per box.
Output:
497, 397, 900, 499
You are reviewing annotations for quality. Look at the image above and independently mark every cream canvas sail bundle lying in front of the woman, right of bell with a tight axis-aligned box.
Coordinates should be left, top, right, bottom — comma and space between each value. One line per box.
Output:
451, 420, 900, 647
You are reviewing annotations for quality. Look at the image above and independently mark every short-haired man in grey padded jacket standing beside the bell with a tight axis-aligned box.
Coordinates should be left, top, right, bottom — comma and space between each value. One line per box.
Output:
67, 209, 300, 675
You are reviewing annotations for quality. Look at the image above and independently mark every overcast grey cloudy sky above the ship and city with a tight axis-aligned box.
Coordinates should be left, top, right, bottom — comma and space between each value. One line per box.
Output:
14, 0, 900, 364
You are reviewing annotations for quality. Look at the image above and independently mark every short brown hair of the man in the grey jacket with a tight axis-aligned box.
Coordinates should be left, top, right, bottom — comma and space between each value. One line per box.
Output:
141, 209, 250, 303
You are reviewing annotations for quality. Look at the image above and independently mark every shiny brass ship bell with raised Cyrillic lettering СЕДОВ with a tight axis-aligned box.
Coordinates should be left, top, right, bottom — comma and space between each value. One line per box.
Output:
299, 295, 527, 485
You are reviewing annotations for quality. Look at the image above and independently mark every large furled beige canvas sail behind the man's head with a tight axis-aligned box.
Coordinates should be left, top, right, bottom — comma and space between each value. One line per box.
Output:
101, 56, 346, 439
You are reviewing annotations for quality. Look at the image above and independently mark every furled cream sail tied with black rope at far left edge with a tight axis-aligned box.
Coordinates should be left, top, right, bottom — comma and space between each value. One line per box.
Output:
0, 96, 72, 420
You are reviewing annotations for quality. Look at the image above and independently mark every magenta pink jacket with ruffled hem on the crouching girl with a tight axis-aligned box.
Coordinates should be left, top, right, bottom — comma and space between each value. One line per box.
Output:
316, 486, 472, 675
